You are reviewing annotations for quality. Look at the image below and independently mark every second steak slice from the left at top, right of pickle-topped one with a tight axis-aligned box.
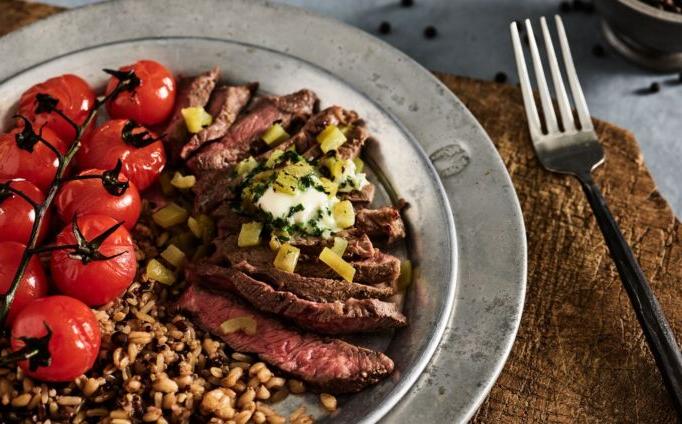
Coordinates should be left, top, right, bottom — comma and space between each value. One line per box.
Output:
180, 82, 258, 159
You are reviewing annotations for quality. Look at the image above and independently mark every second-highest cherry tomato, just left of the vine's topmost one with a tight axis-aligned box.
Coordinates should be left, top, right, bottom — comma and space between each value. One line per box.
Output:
19, 74, 95, 143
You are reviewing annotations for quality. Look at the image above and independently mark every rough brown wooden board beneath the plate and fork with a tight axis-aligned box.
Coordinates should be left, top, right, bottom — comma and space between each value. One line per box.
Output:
0, 0, 682, 424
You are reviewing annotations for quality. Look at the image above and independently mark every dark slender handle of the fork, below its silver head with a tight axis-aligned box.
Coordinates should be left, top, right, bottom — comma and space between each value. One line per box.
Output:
578, 174, 682, 416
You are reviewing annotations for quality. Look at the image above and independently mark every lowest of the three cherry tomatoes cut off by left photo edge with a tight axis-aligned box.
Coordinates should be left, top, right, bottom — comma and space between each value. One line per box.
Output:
0, 241, 48, 325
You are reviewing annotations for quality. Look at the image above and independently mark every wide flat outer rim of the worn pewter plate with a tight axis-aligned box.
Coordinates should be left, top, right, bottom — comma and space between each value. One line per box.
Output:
0, 0, 526, 422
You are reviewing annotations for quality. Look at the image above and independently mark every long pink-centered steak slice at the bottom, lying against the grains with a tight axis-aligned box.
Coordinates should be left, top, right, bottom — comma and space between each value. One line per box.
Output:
176, 284, 393, 394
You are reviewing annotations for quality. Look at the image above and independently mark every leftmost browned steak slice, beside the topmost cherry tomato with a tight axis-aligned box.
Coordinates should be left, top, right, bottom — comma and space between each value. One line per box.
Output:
165, 67, 219, 161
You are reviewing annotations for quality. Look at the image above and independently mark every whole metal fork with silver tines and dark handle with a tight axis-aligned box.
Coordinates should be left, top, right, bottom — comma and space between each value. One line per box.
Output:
511, 16, 682, 417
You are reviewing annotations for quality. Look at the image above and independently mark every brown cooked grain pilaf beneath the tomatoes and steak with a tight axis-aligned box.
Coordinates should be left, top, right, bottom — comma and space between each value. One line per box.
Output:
0, 200, 324, 424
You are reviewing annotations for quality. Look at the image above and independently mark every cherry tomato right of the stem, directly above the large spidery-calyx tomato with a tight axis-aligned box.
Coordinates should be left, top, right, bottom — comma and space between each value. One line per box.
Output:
55, 169, 142, 229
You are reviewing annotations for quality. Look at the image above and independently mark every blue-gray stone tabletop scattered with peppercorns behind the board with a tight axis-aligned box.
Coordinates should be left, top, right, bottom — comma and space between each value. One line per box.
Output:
45, 0, 682, 216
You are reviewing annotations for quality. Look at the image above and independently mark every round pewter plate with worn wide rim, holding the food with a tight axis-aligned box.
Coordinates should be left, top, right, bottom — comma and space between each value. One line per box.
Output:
0, 0, 526, 422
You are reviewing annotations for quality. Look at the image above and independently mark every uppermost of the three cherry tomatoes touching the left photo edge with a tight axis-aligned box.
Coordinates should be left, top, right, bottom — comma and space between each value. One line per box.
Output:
0, 128, 66, 190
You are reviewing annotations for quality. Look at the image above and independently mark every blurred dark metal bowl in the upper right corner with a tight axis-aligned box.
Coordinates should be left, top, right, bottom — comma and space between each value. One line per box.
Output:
595, 0, 682, 72
